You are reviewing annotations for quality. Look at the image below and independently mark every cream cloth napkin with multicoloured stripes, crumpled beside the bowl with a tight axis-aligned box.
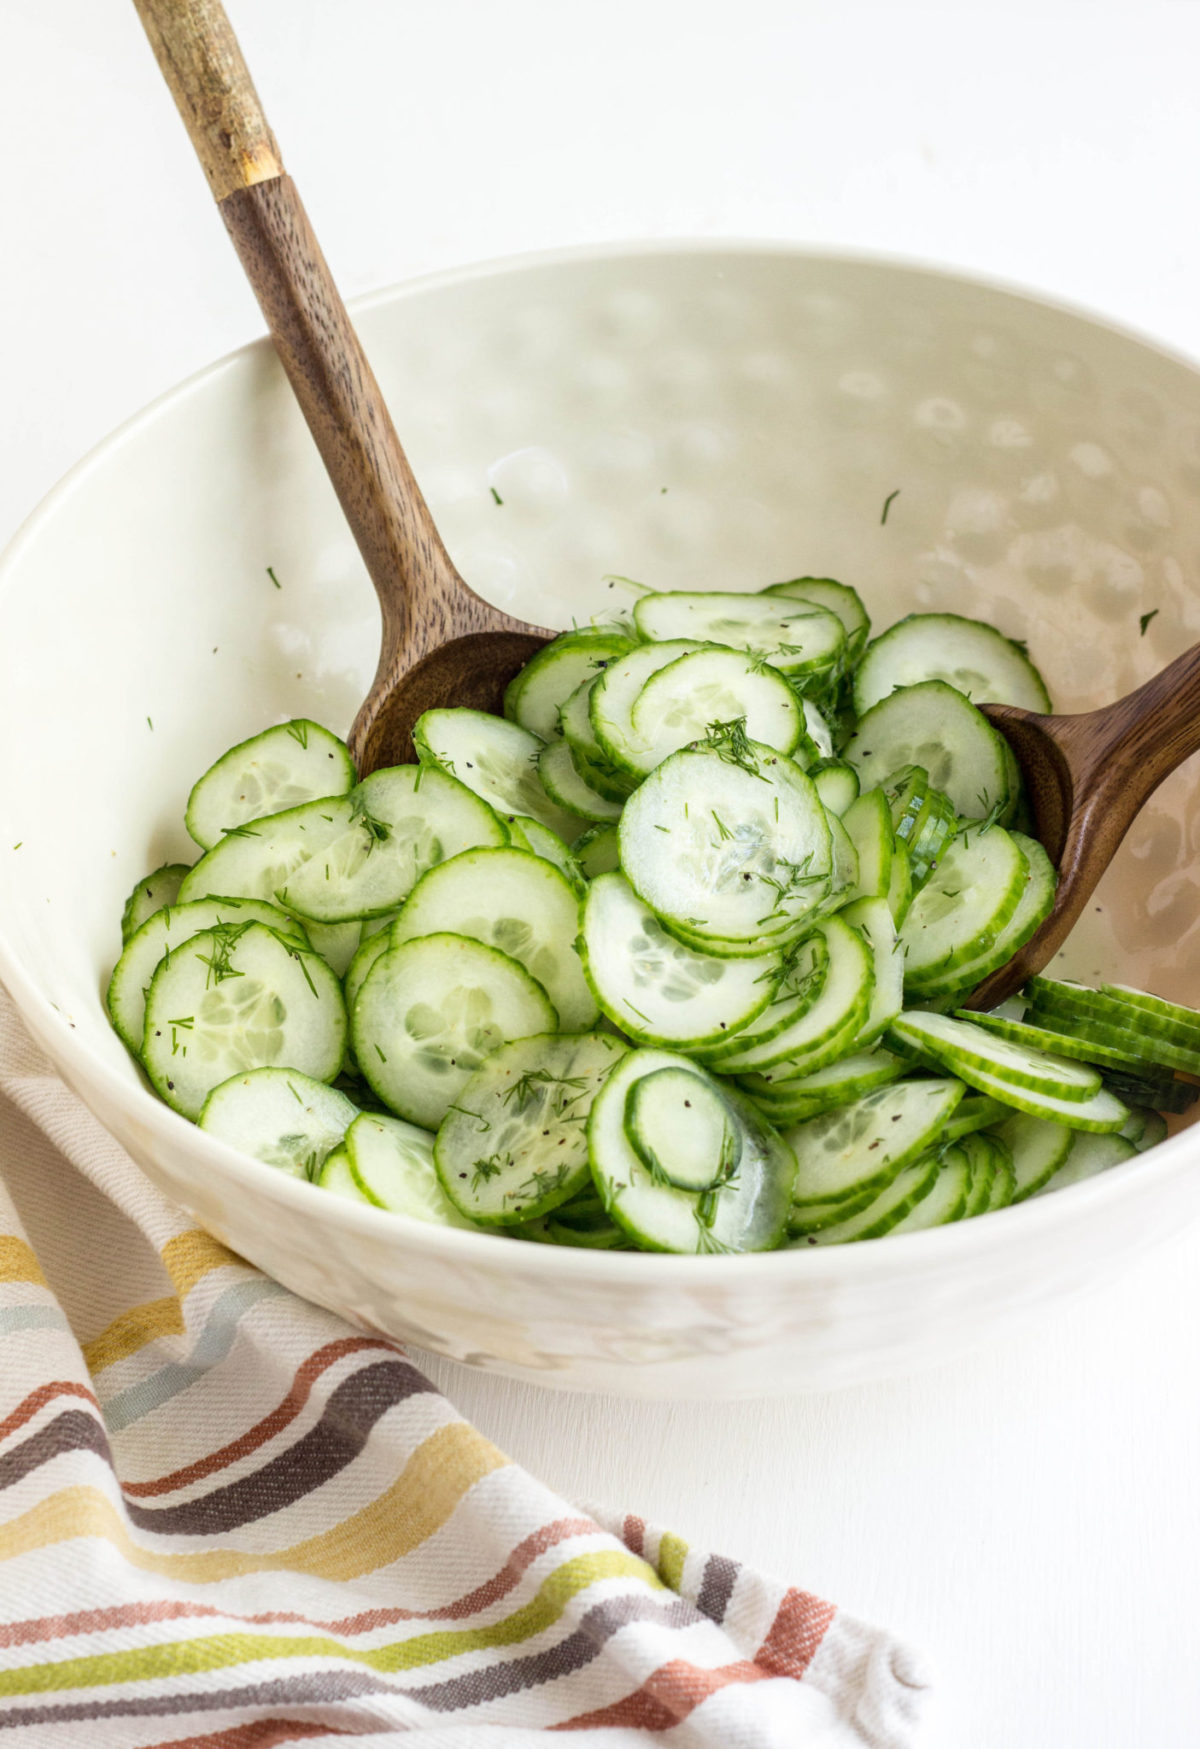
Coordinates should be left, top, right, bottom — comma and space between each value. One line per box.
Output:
0, 990, 927, 1749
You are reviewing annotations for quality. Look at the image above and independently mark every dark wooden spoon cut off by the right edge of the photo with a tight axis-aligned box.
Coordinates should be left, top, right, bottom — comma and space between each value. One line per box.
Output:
966, 644, 1200, 1009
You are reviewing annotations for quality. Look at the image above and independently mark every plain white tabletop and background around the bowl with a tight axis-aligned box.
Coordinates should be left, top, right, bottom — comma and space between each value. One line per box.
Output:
0, 0, 1200, 1749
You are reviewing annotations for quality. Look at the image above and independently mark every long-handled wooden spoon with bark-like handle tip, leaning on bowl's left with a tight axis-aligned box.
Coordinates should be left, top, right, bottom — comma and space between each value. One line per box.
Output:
135, 0, 555, 775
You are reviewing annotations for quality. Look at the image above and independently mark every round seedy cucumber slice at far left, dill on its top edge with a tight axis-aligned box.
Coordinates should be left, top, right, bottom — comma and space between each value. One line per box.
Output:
142, 920, 346, 1118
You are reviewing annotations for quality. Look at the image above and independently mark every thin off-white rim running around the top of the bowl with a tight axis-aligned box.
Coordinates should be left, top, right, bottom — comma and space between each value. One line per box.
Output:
0, 236, 1200, 1289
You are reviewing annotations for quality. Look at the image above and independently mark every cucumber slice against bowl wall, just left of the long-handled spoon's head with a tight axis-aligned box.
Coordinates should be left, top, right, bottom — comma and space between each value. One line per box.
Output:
184, 717, 357, 850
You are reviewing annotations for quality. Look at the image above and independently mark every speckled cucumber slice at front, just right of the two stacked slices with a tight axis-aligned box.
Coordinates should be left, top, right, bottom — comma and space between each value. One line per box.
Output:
785, 1079, 964, 1210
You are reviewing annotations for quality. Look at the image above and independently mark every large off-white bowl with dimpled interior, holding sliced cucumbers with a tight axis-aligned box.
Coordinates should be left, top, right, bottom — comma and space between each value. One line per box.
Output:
0, 243, 1200, 1396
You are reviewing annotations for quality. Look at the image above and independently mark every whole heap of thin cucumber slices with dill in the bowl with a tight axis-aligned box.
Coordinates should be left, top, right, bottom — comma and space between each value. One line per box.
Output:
107, 577, 1200, 1254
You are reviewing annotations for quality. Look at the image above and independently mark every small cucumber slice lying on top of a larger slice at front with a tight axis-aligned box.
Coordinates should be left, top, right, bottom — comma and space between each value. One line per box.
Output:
624, 1069, 742, 1191
